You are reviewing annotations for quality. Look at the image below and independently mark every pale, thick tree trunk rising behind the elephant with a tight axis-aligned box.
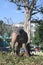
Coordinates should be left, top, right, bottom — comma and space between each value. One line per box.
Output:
24, 7, 30, 43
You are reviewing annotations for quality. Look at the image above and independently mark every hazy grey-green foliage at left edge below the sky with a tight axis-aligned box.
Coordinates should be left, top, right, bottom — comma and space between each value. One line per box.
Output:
0, 20, 12, 36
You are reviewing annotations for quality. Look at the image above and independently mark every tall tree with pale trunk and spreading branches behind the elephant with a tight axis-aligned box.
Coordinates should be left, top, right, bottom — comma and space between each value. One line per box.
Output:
9, 0, 43, 42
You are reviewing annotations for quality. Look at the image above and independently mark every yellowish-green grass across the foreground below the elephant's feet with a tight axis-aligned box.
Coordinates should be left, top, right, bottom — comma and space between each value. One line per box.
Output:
0, 52, 43, 65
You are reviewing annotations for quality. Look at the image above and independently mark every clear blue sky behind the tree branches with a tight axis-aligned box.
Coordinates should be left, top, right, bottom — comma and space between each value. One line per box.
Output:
0, 0, 43, 24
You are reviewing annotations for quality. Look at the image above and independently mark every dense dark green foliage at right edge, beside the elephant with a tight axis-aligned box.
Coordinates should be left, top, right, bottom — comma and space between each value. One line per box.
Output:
33, 21, 43, 45
